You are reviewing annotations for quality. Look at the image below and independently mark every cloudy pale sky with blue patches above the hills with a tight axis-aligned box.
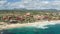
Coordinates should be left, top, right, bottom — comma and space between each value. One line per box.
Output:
0, 0, 60, 10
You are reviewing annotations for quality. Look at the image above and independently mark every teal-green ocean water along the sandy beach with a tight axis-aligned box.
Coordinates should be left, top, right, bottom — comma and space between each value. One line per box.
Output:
2, 24, 60, 34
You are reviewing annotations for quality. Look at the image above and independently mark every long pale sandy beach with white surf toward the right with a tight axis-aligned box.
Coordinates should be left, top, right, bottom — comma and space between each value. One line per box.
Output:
0, 20, 60, 30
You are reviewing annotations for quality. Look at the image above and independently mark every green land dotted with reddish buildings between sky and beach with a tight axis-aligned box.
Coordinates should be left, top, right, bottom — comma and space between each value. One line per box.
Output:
0, 10, 60, 23
